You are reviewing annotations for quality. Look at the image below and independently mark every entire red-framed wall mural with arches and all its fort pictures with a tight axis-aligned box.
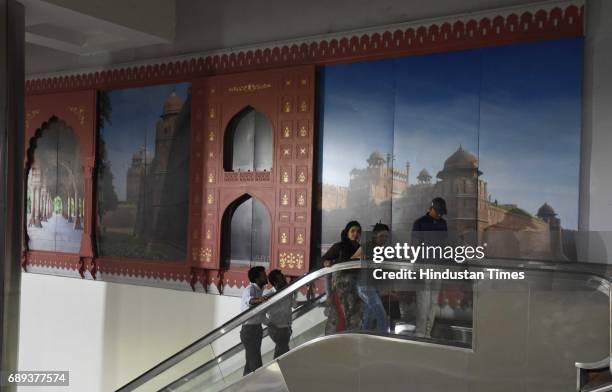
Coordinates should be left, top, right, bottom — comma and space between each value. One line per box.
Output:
22, 4, 583, 290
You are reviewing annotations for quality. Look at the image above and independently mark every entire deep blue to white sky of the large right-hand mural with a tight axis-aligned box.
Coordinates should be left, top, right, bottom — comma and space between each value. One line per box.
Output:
320, 39, 582, 228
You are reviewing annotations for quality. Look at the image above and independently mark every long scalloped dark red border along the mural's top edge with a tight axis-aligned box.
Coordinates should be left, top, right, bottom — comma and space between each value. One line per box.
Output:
26, 5, 584, 94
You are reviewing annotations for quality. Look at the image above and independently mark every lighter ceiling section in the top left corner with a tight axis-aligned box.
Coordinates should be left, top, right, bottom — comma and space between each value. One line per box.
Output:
20, 0, 176, 57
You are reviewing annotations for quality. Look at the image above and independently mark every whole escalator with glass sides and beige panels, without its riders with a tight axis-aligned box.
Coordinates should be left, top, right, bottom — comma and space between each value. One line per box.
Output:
118, 261, 610, 392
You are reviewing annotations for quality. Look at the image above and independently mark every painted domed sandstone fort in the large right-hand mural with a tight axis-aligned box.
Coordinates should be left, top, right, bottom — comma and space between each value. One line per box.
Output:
321, 146, 567, 260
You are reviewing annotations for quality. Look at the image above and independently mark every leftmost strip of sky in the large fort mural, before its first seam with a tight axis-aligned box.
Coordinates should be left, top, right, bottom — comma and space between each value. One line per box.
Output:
319, 61, 395, 181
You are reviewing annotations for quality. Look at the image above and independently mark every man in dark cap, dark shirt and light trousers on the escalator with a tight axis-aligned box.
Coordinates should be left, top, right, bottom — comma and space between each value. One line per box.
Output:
412, 197, 448, 338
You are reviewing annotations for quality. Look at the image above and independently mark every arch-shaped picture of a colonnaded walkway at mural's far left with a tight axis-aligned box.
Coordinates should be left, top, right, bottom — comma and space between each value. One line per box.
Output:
26, 118, 85, 253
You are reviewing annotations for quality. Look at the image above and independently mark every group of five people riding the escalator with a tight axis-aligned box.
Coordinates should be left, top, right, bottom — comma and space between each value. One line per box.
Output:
240, 198, 447, 375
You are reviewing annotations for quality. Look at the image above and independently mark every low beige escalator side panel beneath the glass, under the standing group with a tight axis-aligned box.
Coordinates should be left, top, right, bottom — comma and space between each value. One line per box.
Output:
278, 334, 472, 392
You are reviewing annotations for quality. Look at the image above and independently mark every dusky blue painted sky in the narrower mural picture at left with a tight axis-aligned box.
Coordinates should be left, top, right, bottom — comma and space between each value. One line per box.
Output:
101, 83, 190, 200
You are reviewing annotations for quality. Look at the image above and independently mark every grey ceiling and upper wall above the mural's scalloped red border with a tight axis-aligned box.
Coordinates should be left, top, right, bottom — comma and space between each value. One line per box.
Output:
20, 0, 548, 75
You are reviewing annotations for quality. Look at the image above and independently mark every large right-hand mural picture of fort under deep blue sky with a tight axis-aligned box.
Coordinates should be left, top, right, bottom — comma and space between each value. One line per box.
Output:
320, 39, 582, 261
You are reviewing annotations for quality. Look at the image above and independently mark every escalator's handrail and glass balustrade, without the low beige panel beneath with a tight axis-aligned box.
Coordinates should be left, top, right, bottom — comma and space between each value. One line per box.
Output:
119, 261, 610, 391
